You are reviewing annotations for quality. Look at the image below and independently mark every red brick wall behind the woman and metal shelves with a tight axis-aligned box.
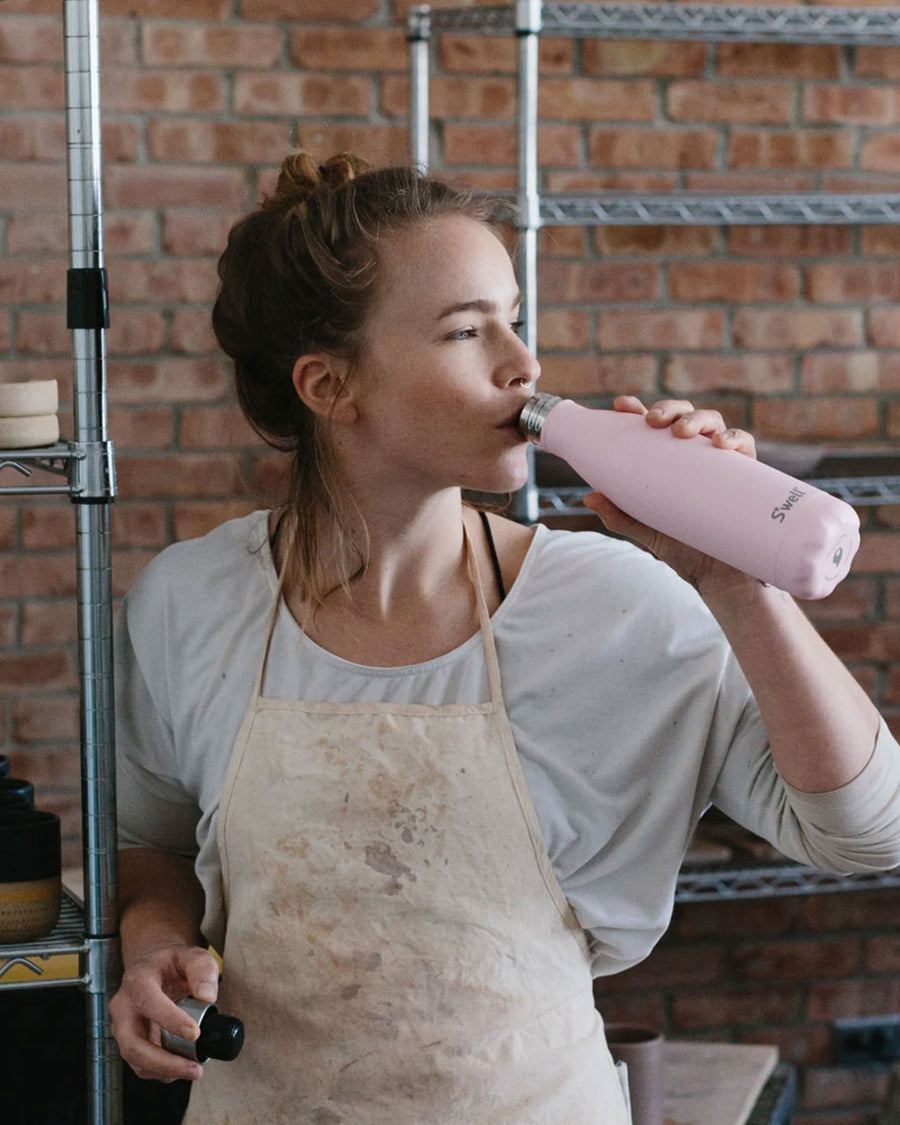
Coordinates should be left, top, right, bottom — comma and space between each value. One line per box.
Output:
0, 0, 900, 1125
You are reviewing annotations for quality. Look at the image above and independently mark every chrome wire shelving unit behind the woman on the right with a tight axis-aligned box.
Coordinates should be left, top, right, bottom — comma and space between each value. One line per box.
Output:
406, 0, 900, 902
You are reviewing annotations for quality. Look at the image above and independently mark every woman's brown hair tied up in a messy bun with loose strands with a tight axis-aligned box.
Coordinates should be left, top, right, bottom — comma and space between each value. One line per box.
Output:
213, 152, 511, 606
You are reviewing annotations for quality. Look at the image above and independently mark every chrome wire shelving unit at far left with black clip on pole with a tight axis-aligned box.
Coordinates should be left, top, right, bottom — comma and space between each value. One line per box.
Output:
0, 0, 122, 1125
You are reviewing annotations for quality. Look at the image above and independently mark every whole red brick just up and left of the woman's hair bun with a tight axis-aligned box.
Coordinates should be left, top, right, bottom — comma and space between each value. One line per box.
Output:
147, 118, 291, 164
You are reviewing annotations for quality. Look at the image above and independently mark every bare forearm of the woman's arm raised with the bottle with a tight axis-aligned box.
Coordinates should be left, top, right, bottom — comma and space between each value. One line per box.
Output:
700, 575, 880, 792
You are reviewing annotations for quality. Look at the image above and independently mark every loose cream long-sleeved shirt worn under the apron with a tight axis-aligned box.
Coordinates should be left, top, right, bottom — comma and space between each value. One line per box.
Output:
116, 512, 900, 975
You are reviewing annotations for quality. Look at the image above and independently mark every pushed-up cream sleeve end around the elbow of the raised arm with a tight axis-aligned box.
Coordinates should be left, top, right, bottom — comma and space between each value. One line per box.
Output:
712, 708, 900, 874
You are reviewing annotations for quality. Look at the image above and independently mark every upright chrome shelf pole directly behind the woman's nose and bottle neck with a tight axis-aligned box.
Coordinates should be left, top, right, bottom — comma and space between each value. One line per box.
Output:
513, 0, 541, 523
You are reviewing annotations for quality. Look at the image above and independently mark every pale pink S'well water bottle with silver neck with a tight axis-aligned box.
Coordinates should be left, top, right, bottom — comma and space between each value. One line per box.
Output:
519, 395, 860, 599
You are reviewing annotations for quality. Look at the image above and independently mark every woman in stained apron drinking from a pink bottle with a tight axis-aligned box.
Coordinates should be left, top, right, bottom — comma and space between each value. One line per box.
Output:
111, 154, 900, 1125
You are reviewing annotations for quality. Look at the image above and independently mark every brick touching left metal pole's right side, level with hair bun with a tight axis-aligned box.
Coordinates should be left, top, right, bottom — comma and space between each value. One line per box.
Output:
105, 164, 246, 210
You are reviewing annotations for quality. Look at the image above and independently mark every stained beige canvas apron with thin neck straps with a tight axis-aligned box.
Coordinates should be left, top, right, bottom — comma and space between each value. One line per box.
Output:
185, 528, 628, 1125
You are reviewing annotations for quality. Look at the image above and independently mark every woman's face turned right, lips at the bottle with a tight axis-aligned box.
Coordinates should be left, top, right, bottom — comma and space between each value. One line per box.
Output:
344, 215, 540, 492
